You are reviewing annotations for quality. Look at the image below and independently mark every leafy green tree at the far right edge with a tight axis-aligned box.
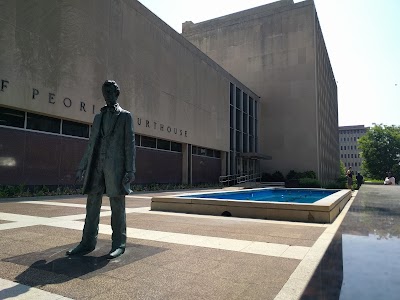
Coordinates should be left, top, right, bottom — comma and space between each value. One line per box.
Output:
358, 124, 400, 180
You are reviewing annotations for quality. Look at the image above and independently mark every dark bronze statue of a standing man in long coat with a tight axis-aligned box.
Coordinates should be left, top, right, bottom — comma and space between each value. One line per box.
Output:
66, 80, 136, 259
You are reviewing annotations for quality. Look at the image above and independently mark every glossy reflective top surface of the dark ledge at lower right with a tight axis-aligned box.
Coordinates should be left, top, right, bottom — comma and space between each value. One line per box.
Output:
301, 185, 400, 300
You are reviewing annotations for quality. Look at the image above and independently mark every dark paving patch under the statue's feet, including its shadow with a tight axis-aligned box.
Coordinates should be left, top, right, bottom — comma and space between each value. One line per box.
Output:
2, 240, 166, 286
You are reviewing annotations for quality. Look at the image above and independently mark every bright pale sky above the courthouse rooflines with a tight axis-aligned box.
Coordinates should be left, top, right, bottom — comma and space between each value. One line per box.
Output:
139, 0, 400, 126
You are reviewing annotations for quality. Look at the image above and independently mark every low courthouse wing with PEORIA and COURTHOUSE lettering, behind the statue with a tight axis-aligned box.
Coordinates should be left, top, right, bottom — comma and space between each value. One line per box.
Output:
0, 0, 259, 185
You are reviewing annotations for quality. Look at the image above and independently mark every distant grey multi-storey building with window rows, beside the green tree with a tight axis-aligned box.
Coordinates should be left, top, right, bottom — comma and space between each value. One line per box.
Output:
339, 125, 369, 173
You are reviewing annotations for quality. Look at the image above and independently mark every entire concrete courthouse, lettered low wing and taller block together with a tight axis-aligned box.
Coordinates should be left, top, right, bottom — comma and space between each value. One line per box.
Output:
0, 0, 339, 185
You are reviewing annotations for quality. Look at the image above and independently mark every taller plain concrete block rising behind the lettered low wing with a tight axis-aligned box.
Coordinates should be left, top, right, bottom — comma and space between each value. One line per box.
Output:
182, 0, 339, 182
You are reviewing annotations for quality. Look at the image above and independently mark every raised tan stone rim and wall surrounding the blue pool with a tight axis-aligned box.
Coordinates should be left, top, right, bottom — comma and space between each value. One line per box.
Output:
151, 188, 351, 223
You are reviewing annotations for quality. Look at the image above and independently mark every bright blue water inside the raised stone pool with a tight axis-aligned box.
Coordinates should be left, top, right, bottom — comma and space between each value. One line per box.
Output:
180, 188, 338, 203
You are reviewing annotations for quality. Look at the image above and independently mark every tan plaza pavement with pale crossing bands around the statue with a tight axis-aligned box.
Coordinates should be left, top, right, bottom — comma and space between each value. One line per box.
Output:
0, 190, 356, 300
